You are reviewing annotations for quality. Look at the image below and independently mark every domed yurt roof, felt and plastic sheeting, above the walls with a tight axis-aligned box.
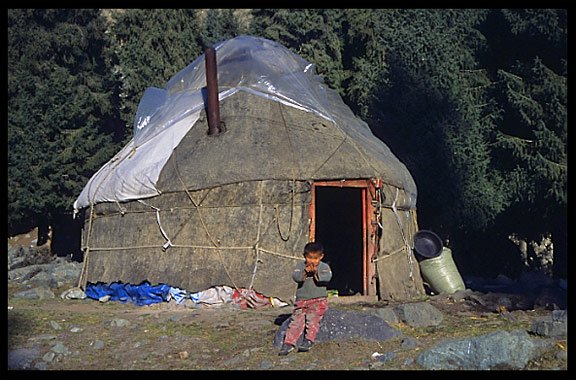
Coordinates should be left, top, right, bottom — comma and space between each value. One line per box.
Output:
74, 36, 416, 209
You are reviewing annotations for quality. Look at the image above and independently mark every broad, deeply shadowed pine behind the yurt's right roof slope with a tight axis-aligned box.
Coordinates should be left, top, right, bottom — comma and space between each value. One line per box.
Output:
349, 9, 508, 231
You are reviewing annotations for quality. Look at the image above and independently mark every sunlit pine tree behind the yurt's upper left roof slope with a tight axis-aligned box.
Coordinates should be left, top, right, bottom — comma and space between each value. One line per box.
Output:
111, 9, 203, 132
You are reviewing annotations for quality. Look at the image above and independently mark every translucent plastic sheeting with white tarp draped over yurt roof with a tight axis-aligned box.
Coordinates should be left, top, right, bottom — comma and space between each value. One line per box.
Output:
74, 36, 416, 210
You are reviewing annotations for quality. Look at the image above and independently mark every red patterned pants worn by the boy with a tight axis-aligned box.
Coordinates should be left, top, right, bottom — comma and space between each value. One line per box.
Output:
284, 298, 328, 346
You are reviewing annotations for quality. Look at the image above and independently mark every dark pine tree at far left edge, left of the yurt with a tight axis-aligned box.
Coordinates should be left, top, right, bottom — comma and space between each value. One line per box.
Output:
8, 9, 123, 233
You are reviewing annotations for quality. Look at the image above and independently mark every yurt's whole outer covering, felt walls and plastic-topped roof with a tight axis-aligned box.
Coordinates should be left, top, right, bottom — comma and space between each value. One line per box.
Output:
74, 36, 423, 300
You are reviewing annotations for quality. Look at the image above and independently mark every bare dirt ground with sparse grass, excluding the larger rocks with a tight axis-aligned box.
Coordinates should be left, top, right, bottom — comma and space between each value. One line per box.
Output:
8, 284, 567, 370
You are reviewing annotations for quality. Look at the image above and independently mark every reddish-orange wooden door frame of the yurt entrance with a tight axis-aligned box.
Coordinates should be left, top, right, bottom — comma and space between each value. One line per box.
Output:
309, 179, 380, 296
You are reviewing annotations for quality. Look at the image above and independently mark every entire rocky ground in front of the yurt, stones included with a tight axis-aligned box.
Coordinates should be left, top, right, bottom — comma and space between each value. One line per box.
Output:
7, 230, 568, 373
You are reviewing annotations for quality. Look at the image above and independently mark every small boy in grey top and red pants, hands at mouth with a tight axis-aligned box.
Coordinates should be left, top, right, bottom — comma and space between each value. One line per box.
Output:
278, 243, 332, 355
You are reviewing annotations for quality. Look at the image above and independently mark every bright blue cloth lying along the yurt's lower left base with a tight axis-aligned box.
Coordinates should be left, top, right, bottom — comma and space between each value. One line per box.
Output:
84, 282, 171, 306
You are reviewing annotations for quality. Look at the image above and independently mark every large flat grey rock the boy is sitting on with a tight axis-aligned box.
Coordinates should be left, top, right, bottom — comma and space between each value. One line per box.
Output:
274, 308, 402, 349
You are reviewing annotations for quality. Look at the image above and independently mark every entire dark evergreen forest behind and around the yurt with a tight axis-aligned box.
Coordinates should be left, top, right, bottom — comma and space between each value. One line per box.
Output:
6, 8, 568, 277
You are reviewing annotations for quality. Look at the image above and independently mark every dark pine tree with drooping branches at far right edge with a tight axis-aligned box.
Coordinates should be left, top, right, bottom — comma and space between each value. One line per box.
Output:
480, 9, 568, 276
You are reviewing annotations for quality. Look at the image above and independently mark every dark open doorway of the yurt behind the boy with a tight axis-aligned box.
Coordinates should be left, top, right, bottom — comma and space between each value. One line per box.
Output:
315, 186, 364, 295
